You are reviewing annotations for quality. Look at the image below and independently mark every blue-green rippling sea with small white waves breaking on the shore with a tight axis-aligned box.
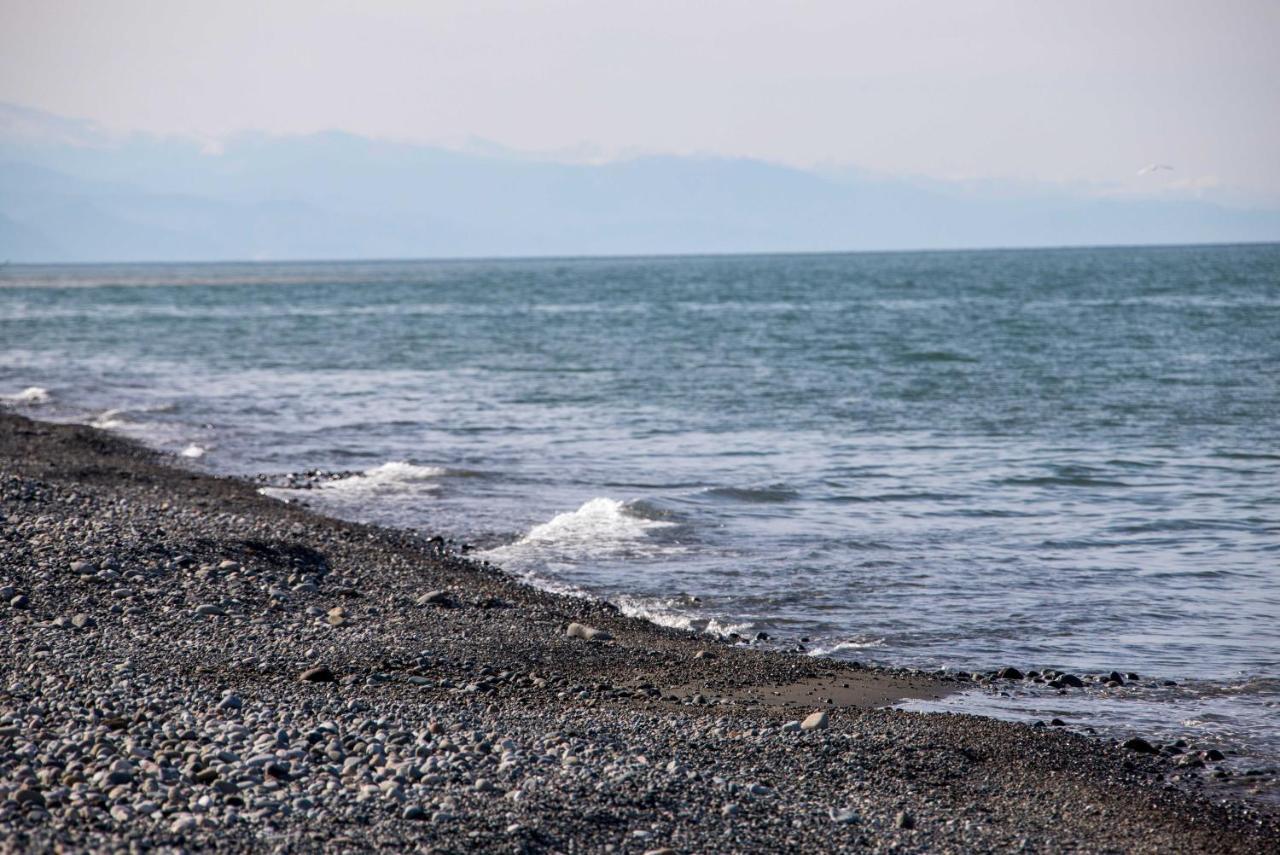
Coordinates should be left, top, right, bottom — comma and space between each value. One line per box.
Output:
0, 246, 1280, 783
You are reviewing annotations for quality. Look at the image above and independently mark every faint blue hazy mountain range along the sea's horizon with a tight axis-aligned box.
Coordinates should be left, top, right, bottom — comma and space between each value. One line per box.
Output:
0, 104, 1280, 262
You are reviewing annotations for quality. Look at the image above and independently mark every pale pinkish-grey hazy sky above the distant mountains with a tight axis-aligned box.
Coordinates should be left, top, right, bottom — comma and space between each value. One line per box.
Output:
0, 0, 1280, 204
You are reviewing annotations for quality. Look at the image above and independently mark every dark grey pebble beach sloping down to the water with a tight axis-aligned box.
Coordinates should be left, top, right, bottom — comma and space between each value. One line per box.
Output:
0, 413, 1280, 852
